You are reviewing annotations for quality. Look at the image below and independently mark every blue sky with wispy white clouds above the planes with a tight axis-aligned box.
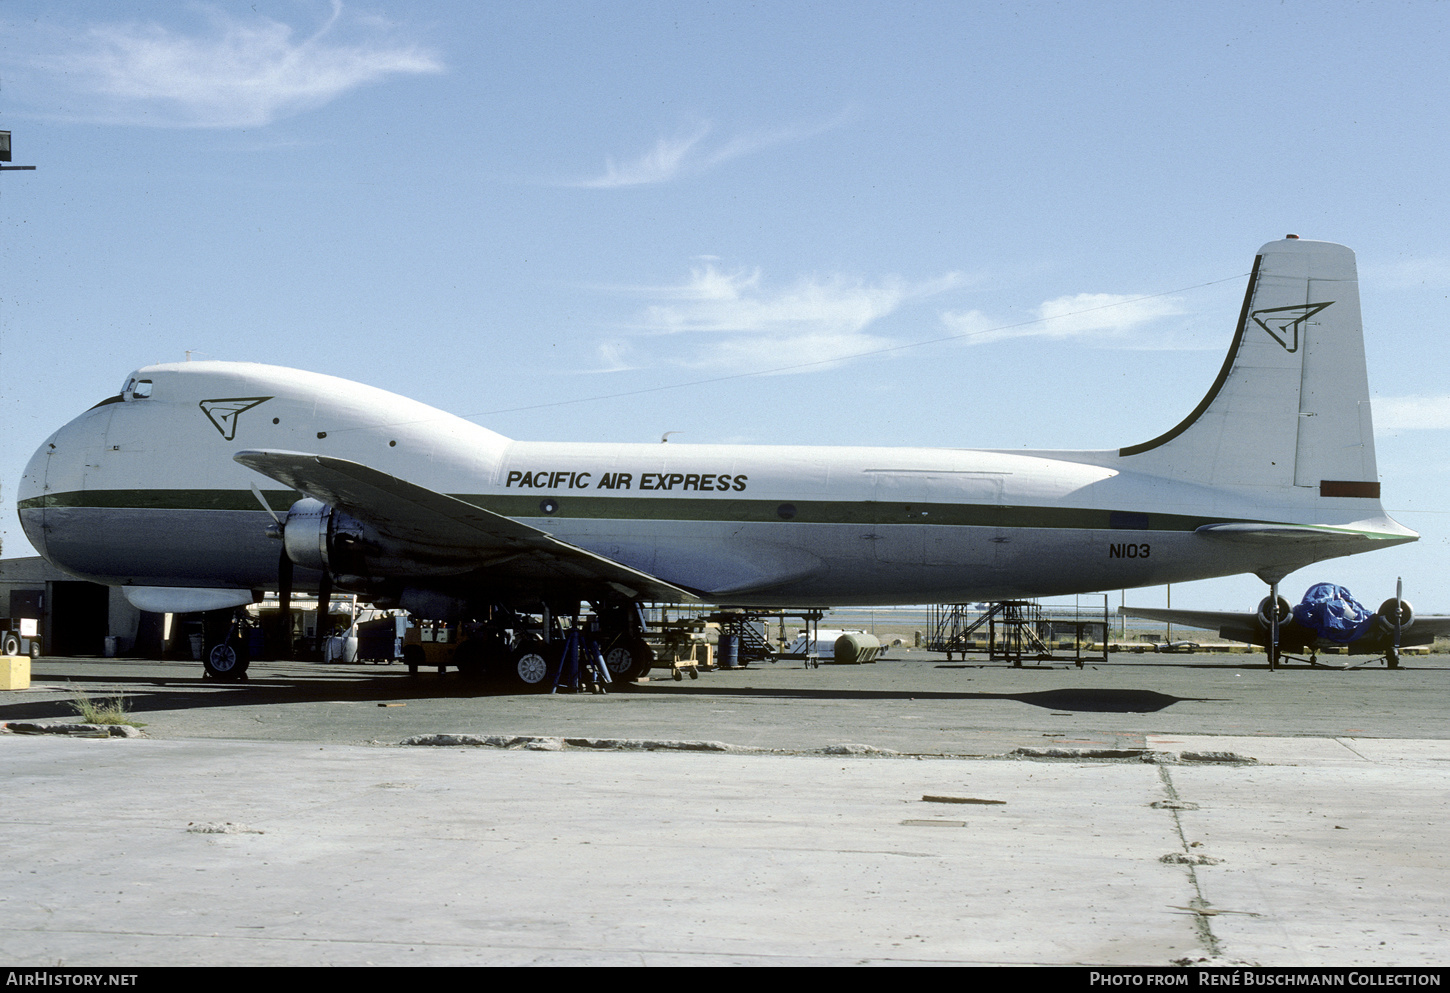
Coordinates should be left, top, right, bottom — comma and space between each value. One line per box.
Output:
0, 0, 1450, 612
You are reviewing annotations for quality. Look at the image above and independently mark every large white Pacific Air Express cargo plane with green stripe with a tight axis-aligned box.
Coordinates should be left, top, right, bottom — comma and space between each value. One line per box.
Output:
17, 235, 1418, 684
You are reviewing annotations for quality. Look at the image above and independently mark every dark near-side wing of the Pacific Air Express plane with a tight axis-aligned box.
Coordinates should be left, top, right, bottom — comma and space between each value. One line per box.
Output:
233, 451, 699, 603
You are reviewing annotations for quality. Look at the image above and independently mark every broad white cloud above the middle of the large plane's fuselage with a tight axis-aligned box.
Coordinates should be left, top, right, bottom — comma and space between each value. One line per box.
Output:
602, 264, 966, 373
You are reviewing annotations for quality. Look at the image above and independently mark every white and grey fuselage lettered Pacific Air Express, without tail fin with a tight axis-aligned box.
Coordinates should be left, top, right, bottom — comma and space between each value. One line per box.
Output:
19, 356, 1409, 606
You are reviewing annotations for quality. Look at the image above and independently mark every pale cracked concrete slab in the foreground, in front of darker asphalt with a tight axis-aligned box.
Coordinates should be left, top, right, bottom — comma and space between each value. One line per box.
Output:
0, 735, 1450, 965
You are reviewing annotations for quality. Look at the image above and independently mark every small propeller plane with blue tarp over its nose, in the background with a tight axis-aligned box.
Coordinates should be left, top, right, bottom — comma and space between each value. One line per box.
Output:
1118, 583, 1450, 668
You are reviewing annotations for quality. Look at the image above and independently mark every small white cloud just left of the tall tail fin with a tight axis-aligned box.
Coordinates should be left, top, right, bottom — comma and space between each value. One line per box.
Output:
941, 293, 1188, 345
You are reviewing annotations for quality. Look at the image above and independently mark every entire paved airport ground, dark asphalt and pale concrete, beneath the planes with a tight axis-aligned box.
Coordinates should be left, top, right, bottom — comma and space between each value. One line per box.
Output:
0, 649, 1450, 970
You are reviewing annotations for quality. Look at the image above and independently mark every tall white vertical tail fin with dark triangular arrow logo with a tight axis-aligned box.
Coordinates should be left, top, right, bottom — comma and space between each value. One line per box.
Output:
1118, 236, 1379, 499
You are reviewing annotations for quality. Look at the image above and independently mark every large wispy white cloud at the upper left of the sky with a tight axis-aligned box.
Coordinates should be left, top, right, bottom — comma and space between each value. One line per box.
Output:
35, 0, 442, 128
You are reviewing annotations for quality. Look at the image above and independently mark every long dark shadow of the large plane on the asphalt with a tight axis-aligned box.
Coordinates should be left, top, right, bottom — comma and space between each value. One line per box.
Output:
0, 667, 1212, 720
